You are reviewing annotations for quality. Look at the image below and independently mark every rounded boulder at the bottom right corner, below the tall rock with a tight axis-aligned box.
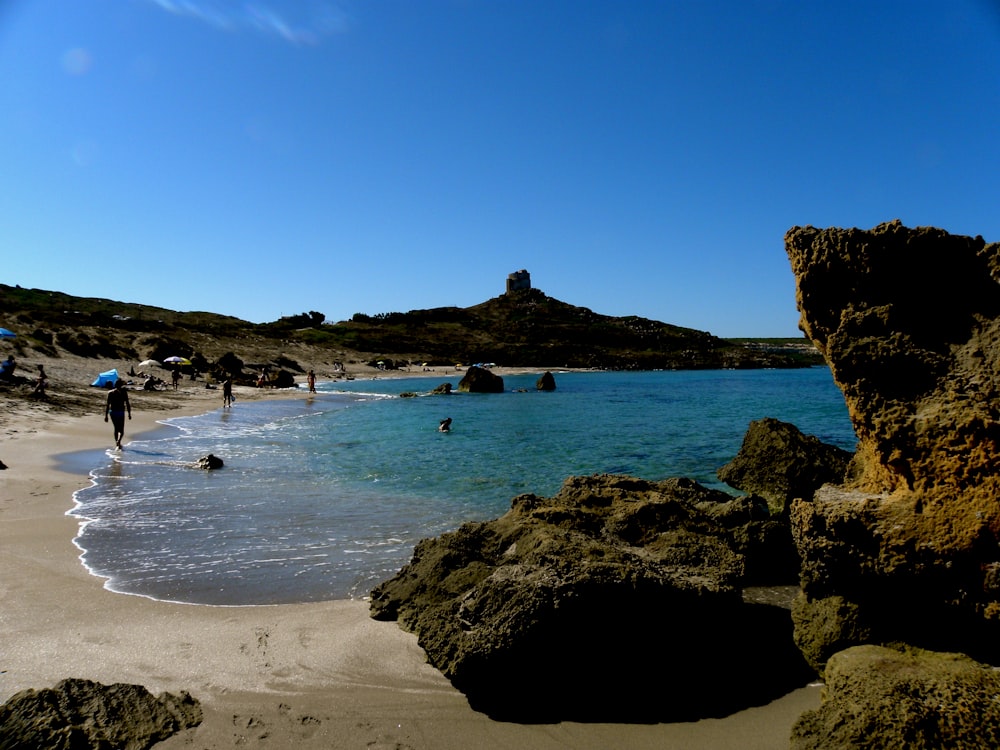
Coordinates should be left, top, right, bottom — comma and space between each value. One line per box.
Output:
791, 646, 1000, 750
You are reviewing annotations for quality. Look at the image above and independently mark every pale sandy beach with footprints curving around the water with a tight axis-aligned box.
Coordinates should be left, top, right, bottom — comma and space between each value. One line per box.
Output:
0, 360, 819, 750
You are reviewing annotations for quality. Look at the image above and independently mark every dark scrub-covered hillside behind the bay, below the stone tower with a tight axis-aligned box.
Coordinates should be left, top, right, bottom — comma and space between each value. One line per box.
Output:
0, 285, 822, 370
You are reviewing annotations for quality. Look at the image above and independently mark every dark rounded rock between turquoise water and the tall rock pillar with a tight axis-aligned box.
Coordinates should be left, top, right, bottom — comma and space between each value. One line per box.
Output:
717, 417, 851, 516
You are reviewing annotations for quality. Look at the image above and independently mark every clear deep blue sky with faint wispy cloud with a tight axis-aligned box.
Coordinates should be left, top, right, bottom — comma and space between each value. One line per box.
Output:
0, 0, 1000, 336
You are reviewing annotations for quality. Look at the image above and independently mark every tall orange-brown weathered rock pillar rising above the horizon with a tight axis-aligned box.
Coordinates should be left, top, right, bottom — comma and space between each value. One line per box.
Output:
785, 221, 1000, 669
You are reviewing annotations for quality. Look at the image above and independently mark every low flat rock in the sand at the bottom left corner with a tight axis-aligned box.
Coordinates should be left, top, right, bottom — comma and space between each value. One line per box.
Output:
0, 679, 202, 750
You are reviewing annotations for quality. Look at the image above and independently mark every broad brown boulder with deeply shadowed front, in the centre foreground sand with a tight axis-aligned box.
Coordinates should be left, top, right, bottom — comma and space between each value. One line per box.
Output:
371, 475, 807, 721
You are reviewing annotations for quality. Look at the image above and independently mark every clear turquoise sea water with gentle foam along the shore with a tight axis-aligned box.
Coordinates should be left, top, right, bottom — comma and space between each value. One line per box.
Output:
71, 367, 855, 605
